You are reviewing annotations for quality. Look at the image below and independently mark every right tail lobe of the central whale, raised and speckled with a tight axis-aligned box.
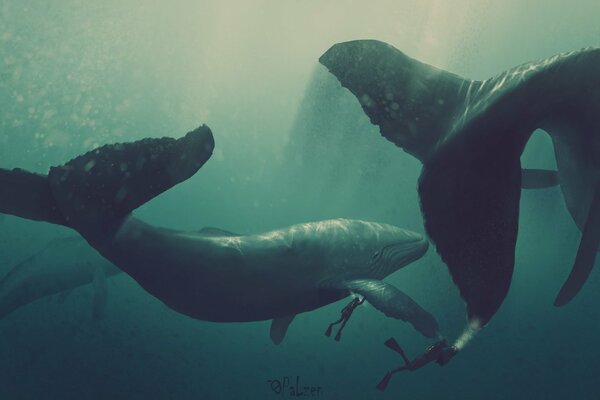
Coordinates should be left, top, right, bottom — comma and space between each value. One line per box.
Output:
48, 125, 214, 236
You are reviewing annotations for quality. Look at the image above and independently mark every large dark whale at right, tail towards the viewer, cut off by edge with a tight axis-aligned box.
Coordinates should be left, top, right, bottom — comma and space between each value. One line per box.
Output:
319, 40, 600, 344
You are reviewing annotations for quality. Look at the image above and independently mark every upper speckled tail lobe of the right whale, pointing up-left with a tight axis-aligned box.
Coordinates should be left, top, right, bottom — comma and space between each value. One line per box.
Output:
319, 40, 481, 161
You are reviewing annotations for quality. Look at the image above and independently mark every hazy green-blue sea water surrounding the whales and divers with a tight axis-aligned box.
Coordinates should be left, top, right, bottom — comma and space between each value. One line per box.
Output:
0, 0, 600, 399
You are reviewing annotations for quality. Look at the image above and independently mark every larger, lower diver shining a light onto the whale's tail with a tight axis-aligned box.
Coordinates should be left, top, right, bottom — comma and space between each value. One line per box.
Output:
377, 338, 458, 390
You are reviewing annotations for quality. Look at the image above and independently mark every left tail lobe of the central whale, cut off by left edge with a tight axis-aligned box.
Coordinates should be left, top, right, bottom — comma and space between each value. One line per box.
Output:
0, 168, 67, 225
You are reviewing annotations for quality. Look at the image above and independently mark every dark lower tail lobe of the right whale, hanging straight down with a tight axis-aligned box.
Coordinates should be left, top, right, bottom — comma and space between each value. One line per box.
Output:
419, 132, 521, 326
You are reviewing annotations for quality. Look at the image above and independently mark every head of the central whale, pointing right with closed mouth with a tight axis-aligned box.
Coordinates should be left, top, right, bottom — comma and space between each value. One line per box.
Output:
312, 220, 429, 279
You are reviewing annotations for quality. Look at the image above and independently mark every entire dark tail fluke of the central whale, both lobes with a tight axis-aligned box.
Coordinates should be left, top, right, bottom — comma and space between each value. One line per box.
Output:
0, 125, 214, 236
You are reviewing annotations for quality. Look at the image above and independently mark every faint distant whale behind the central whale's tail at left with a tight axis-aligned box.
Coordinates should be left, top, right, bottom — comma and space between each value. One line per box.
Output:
0, 236, 122, 319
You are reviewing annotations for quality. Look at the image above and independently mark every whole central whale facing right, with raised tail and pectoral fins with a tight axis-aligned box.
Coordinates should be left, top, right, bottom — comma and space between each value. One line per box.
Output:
0, 125, 438, 343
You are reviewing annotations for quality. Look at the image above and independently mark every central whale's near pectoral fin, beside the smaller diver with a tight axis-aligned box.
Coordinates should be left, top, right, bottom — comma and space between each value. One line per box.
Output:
345, 279, 438, 337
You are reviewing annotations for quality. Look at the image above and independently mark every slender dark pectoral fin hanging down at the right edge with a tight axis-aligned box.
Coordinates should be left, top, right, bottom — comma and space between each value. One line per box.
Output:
554, 183, 600, 307
